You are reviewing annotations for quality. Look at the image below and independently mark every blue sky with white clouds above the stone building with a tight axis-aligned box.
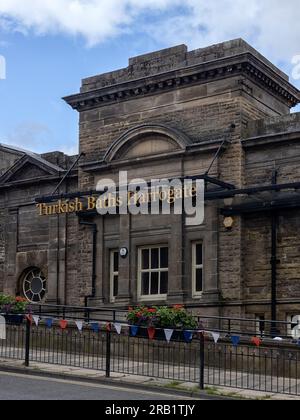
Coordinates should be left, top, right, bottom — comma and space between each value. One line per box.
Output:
0, 0, 300, 154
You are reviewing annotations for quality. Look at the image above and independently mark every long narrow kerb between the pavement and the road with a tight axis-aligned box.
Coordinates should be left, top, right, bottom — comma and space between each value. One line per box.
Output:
0, 365, 237, 401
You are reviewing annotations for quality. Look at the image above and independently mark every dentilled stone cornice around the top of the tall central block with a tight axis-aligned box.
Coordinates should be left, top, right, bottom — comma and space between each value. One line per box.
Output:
63, 53, 300, 112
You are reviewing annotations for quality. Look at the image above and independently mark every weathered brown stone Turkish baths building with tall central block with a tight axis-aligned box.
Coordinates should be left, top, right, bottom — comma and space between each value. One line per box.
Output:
0, 39, 300, 320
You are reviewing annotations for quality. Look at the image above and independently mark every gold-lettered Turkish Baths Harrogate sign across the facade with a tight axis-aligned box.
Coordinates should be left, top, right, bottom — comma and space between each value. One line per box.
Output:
37, 174, 205, 225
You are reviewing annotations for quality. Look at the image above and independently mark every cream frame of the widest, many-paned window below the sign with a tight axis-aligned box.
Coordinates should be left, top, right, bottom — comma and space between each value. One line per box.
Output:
138, 245, 170, 302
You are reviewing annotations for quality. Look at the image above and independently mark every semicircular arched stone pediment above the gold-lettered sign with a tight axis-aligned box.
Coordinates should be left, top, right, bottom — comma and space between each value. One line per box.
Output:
104, 124, 191, 162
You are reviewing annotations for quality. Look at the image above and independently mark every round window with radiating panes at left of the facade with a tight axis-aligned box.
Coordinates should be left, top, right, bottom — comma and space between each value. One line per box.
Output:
23, 268, 47, 303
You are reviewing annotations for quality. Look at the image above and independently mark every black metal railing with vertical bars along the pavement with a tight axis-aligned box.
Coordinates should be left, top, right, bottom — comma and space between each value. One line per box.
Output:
0, 307, 300, 395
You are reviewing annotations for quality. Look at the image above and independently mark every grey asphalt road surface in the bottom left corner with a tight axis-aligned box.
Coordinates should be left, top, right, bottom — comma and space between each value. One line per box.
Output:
0, 372, 200, 401
